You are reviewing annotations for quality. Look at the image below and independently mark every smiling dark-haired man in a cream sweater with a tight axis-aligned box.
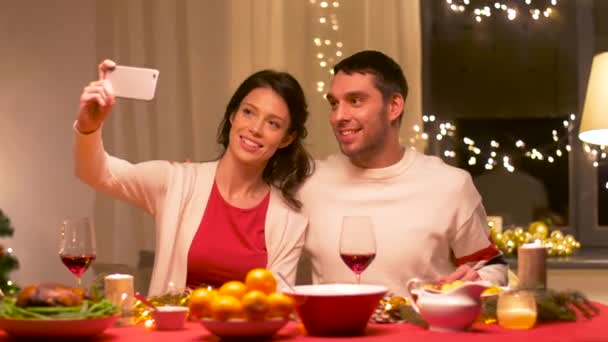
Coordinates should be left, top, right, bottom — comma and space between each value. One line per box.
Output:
301, 51, 507, 294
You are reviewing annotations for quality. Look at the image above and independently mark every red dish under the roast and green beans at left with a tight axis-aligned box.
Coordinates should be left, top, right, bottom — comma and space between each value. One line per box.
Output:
0, 316, 118, 339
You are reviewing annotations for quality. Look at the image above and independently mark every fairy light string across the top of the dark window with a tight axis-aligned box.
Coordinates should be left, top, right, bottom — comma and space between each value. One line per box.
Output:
445, 0, 557, 23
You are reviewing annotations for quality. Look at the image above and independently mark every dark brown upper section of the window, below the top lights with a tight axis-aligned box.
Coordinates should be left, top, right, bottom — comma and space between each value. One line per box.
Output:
422, 0, 576, 119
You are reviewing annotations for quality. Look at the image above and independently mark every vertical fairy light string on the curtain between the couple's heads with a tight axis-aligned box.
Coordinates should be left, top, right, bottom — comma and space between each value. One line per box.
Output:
310, 0, 344, 94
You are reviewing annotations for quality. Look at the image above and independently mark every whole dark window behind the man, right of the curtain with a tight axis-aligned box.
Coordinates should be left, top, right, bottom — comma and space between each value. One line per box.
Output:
421, 0, 608, 246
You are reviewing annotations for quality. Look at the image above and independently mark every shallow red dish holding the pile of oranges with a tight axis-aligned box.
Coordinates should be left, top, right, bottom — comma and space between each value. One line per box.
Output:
201, 319, 288, 338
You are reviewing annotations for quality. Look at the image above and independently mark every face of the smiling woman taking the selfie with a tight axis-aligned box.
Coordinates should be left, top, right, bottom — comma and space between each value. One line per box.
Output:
228, 88, 295, 167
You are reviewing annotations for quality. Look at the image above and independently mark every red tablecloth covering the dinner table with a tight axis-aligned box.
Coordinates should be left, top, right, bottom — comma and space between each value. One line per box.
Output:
0, 303, 608, 342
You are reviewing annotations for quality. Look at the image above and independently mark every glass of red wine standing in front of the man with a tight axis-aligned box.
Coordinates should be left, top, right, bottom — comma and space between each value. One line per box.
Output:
340, 216, 376, 284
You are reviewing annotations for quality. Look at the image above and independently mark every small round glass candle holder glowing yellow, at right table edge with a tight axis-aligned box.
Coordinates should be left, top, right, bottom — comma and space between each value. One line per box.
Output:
496, 290, 537, 329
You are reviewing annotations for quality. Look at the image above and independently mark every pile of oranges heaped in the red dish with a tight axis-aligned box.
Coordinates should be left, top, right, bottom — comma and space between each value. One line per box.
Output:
188, 268, 294, 321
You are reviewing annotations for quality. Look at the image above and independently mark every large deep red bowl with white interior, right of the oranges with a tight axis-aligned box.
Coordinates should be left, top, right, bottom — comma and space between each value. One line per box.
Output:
285, 284, 388, 336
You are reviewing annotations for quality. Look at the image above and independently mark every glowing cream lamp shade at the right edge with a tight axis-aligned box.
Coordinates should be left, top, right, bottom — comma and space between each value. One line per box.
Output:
578, 52, 608, 145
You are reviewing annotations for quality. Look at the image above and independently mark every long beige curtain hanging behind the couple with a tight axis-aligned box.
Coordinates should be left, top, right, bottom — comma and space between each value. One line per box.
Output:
91, 0, 422, 265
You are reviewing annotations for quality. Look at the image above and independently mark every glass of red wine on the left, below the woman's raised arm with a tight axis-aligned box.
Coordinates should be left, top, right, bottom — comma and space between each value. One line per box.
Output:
59, 217, 96, 287
